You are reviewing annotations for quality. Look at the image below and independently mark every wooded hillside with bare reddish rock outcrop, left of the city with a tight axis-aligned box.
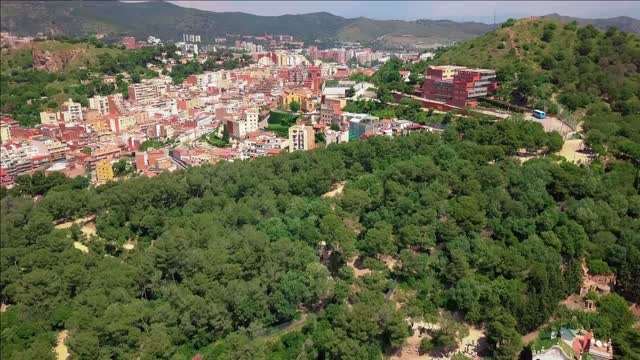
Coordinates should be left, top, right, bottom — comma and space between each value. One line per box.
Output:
0, 38, 163, 126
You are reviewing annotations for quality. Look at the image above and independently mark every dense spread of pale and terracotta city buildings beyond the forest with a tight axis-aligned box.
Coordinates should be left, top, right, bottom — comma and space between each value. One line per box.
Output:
0, 34, 424, 186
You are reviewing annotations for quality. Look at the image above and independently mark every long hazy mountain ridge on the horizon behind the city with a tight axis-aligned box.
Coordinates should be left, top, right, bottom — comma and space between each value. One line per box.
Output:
0, 1, 493, 46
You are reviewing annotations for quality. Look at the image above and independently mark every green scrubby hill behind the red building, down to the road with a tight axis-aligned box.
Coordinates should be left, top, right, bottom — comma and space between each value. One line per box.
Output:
436, 19, 640, 159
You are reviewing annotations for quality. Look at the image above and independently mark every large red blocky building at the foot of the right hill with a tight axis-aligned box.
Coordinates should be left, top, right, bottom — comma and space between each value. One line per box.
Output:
422, 65, 498, 108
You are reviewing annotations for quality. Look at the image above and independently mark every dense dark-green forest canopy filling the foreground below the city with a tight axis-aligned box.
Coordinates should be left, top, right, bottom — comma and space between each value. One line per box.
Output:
0, 119, 640, 359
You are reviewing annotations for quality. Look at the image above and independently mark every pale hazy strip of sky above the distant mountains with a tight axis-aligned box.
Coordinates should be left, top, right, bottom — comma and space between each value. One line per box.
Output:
171, 1, 640, 23
